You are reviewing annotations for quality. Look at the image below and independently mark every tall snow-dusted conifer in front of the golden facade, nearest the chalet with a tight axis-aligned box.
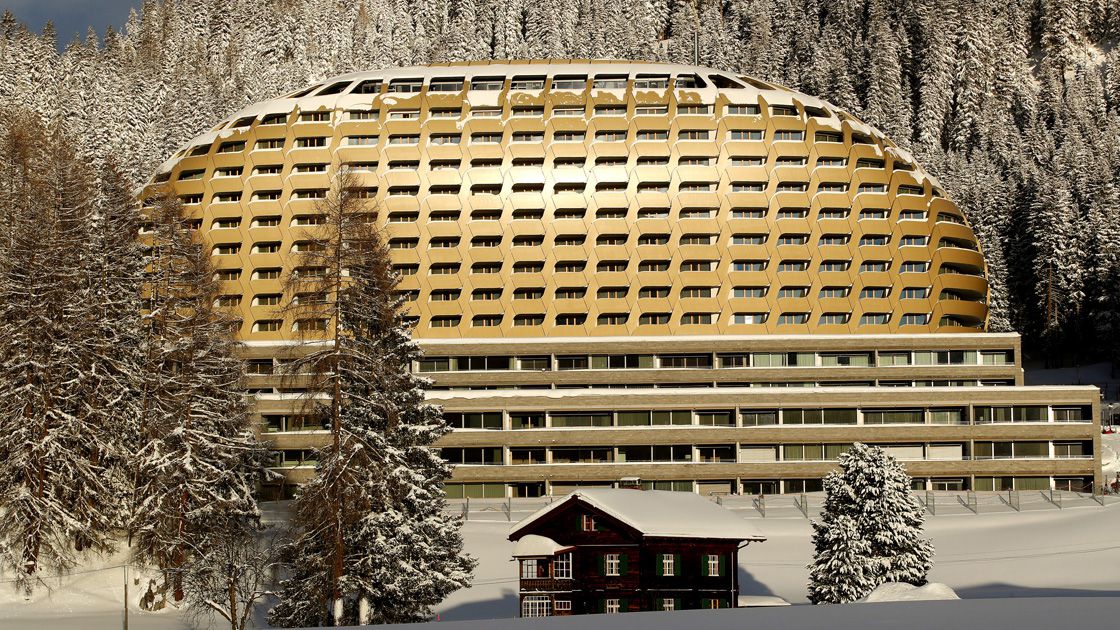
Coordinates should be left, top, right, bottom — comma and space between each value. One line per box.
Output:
269, 173, 474, 627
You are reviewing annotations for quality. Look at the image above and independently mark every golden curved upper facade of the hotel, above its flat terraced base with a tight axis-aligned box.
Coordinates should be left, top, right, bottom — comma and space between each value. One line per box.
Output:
159, 63, 987, 341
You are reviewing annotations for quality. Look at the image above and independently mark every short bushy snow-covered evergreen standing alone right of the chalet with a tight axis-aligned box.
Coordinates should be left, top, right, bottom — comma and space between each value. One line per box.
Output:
809, 443, 933, 604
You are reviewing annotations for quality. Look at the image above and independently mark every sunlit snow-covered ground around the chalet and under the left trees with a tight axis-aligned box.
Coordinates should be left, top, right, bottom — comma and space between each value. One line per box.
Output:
0, 494, 1120, 630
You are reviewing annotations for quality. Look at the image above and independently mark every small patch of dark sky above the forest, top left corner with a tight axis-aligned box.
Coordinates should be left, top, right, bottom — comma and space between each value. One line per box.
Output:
0, 0, 142, 48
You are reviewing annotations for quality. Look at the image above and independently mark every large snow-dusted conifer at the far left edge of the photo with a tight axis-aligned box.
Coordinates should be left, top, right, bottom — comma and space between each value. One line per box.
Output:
0, 111, 121, 593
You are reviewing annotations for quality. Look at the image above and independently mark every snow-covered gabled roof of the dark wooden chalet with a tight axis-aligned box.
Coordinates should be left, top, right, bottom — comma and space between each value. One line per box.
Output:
510, 488, 766, 540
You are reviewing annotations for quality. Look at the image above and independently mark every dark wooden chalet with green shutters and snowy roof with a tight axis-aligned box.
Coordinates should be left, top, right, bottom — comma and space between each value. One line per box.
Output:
510, 489, 765, 617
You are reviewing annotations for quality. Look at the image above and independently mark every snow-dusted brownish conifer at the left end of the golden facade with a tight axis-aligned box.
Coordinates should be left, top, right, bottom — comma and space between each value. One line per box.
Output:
130, 184, 267, 601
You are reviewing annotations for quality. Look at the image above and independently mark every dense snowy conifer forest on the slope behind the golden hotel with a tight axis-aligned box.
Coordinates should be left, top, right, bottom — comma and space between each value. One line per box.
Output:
0, 0, 1120, 365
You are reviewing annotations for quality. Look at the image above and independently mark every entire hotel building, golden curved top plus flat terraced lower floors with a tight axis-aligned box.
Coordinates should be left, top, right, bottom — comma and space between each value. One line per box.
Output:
153, 61, 1100, 497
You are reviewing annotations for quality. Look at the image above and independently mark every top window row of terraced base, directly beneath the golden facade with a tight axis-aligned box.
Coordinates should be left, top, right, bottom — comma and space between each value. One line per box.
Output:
416, 350, 1015, 372
